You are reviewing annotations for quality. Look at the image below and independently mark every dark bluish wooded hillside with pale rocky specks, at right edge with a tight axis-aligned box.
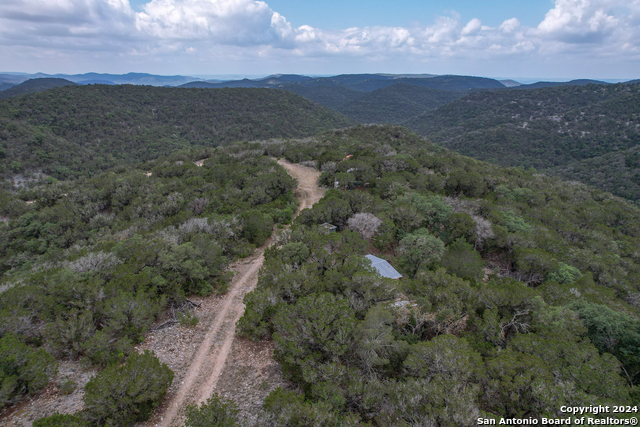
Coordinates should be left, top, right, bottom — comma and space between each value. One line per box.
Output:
404, 84, 640, 200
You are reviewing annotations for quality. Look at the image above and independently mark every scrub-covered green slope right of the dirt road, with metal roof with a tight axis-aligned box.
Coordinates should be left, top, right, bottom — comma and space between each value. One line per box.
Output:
238, 126, 640, 427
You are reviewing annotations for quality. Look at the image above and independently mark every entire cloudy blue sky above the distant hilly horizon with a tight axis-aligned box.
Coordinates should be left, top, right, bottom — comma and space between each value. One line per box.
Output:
0, 0, 640, 79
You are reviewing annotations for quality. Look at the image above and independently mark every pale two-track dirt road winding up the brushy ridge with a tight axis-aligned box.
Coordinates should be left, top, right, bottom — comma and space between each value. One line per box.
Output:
152, 159, 324, 427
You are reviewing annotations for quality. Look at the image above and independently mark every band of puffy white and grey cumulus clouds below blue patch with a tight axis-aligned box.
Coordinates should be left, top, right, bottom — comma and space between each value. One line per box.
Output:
0, 0, 640, 72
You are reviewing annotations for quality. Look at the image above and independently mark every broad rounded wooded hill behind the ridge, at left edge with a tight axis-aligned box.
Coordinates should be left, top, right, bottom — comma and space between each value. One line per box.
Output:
0, 85, 353, 179
